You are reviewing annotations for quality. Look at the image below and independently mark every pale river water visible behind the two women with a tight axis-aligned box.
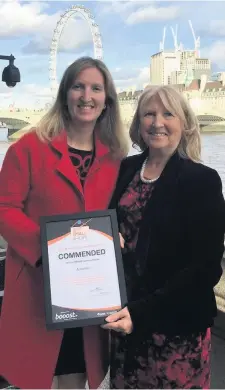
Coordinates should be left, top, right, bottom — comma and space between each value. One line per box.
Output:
0, 133, 225, 195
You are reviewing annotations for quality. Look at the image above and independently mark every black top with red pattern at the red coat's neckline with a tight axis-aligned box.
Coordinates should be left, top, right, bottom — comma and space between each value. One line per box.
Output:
68, 146, 94, 186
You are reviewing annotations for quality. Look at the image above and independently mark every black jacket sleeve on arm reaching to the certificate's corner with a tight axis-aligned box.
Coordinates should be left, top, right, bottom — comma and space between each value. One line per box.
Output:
128, 170, 225, 329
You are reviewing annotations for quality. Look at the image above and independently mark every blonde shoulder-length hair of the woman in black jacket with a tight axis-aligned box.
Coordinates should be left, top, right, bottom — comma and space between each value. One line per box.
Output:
130, 85, 201, 162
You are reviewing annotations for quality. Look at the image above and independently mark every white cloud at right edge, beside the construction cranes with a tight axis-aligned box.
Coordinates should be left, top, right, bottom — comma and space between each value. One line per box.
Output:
201, 40, 225, 69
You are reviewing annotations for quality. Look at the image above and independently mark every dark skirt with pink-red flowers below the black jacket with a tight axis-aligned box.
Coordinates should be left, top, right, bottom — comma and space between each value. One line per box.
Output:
110, 329, 211, 389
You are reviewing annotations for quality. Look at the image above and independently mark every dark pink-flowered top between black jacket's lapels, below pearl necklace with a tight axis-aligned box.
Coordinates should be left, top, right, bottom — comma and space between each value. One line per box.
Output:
118, 171, 155, 253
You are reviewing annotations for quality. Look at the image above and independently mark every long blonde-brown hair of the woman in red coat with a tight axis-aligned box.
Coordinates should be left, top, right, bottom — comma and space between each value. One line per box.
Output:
33, 57, 128, 157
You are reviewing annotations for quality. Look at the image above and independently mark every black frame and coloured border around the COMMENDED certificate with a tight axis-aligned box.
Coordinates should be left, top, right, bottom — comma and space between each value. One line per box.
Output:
40, 209, 127, 330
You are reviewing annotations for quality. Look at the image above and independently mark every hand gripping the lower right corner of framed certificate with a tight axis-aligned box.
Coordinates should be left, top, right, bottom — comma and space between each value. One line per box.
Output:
102, 307, 133, 334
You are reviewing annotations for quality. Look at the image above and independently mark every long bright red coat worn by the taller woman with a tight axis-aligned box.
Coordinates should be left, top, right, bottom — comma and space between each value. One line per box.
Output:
0, 132, 120, 389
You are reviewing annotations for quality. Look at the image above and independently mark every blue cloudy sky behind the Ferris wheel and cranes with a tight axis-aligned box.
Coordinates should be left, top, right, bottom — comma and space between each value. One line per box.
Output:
0, 0, 225, 108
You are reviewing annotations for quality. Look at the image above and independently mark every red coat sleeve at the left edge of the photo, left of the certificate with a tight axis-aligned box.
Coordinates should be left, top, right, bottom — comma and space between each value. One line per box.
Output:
0, 140, 41, 266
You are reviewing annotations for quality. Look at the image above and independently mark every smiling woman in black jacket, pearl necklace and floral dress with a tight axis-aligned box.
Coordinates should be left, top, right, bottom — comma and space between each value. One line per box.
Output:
104, 86, 225, 389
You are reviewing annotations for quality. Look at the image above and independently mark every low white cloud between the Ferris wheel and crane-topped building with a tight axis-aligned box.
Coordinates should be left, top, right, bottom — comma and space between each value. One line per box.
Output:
112, 67, 150, 90
